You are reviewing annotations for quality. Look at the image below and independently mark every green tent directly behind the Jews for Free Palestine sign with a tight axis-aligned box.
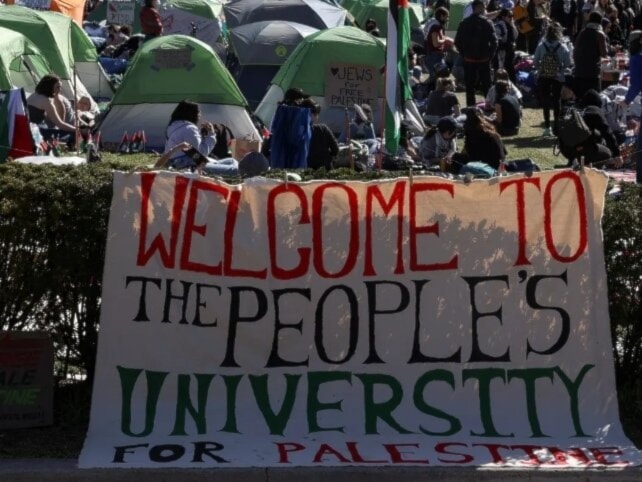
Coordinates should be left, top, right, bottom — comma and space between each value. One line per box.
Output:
256, 27, 385, 132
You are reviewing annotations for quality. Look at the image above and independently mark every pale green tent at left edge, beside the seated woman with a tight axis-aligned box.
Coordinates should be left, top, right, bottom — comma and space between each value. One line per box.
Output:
0, 27, 51, 92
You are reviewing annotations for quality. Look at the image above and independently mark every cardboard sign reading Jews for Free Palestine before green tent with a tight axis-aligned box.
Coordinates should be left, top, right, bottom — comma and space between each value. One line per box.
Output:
325, 62, 381, 107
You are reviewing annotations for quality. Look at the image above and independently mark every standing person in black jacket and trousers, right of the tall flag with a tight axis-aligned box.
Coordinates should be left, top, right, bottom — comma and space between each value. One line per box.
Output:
455, 0, 497, 107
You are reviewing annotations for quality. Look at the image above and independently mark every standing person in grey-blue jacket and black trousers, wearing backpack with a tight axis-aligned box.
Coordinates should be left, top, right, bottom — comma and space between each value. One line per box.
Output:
533, 23, 572, 137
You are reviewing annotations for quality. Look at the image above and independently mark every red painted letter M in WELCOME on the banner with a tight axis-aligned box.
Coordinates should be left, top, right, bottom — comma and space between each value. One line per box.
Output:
363, 182, 406, 276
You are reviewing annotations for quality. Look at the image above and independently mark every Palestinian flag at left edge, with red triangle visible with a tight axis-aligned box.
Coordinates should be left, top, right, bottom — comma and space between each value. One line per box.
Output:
0, 89, 35, 162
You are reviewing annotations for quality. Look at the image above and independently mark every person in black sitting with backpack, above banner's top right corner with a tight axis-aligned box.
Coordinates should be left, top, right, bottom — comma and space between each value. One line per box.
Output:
563, 89, 622, 168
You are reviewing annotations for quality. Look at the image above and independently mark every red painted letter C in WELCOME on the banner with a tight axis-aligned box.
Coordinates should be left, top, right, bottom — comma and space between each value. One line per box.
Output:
267, 184, 311, 280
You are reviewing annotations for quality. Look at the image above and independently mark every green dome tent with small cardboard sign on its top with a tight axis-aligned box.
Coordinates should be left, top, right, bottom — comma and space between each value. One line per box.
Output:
101, 35, 259, 150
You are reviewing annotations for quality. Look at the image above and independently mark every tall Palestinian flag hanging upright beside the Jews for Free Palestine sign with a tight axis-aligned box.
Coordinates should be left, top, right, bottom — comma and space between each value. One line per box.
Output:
385, 0, 412, 154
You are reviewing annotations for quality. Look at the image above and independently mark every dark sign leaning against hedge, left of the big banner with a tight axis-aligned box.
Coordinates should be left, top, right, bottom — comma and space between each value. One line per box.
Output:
0, 331, 54, 429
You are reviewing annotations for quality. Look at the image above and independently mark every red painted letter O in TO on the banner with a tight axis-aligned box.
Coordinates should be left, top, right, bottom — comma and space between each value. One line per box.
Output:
544, 171, 588, 263
